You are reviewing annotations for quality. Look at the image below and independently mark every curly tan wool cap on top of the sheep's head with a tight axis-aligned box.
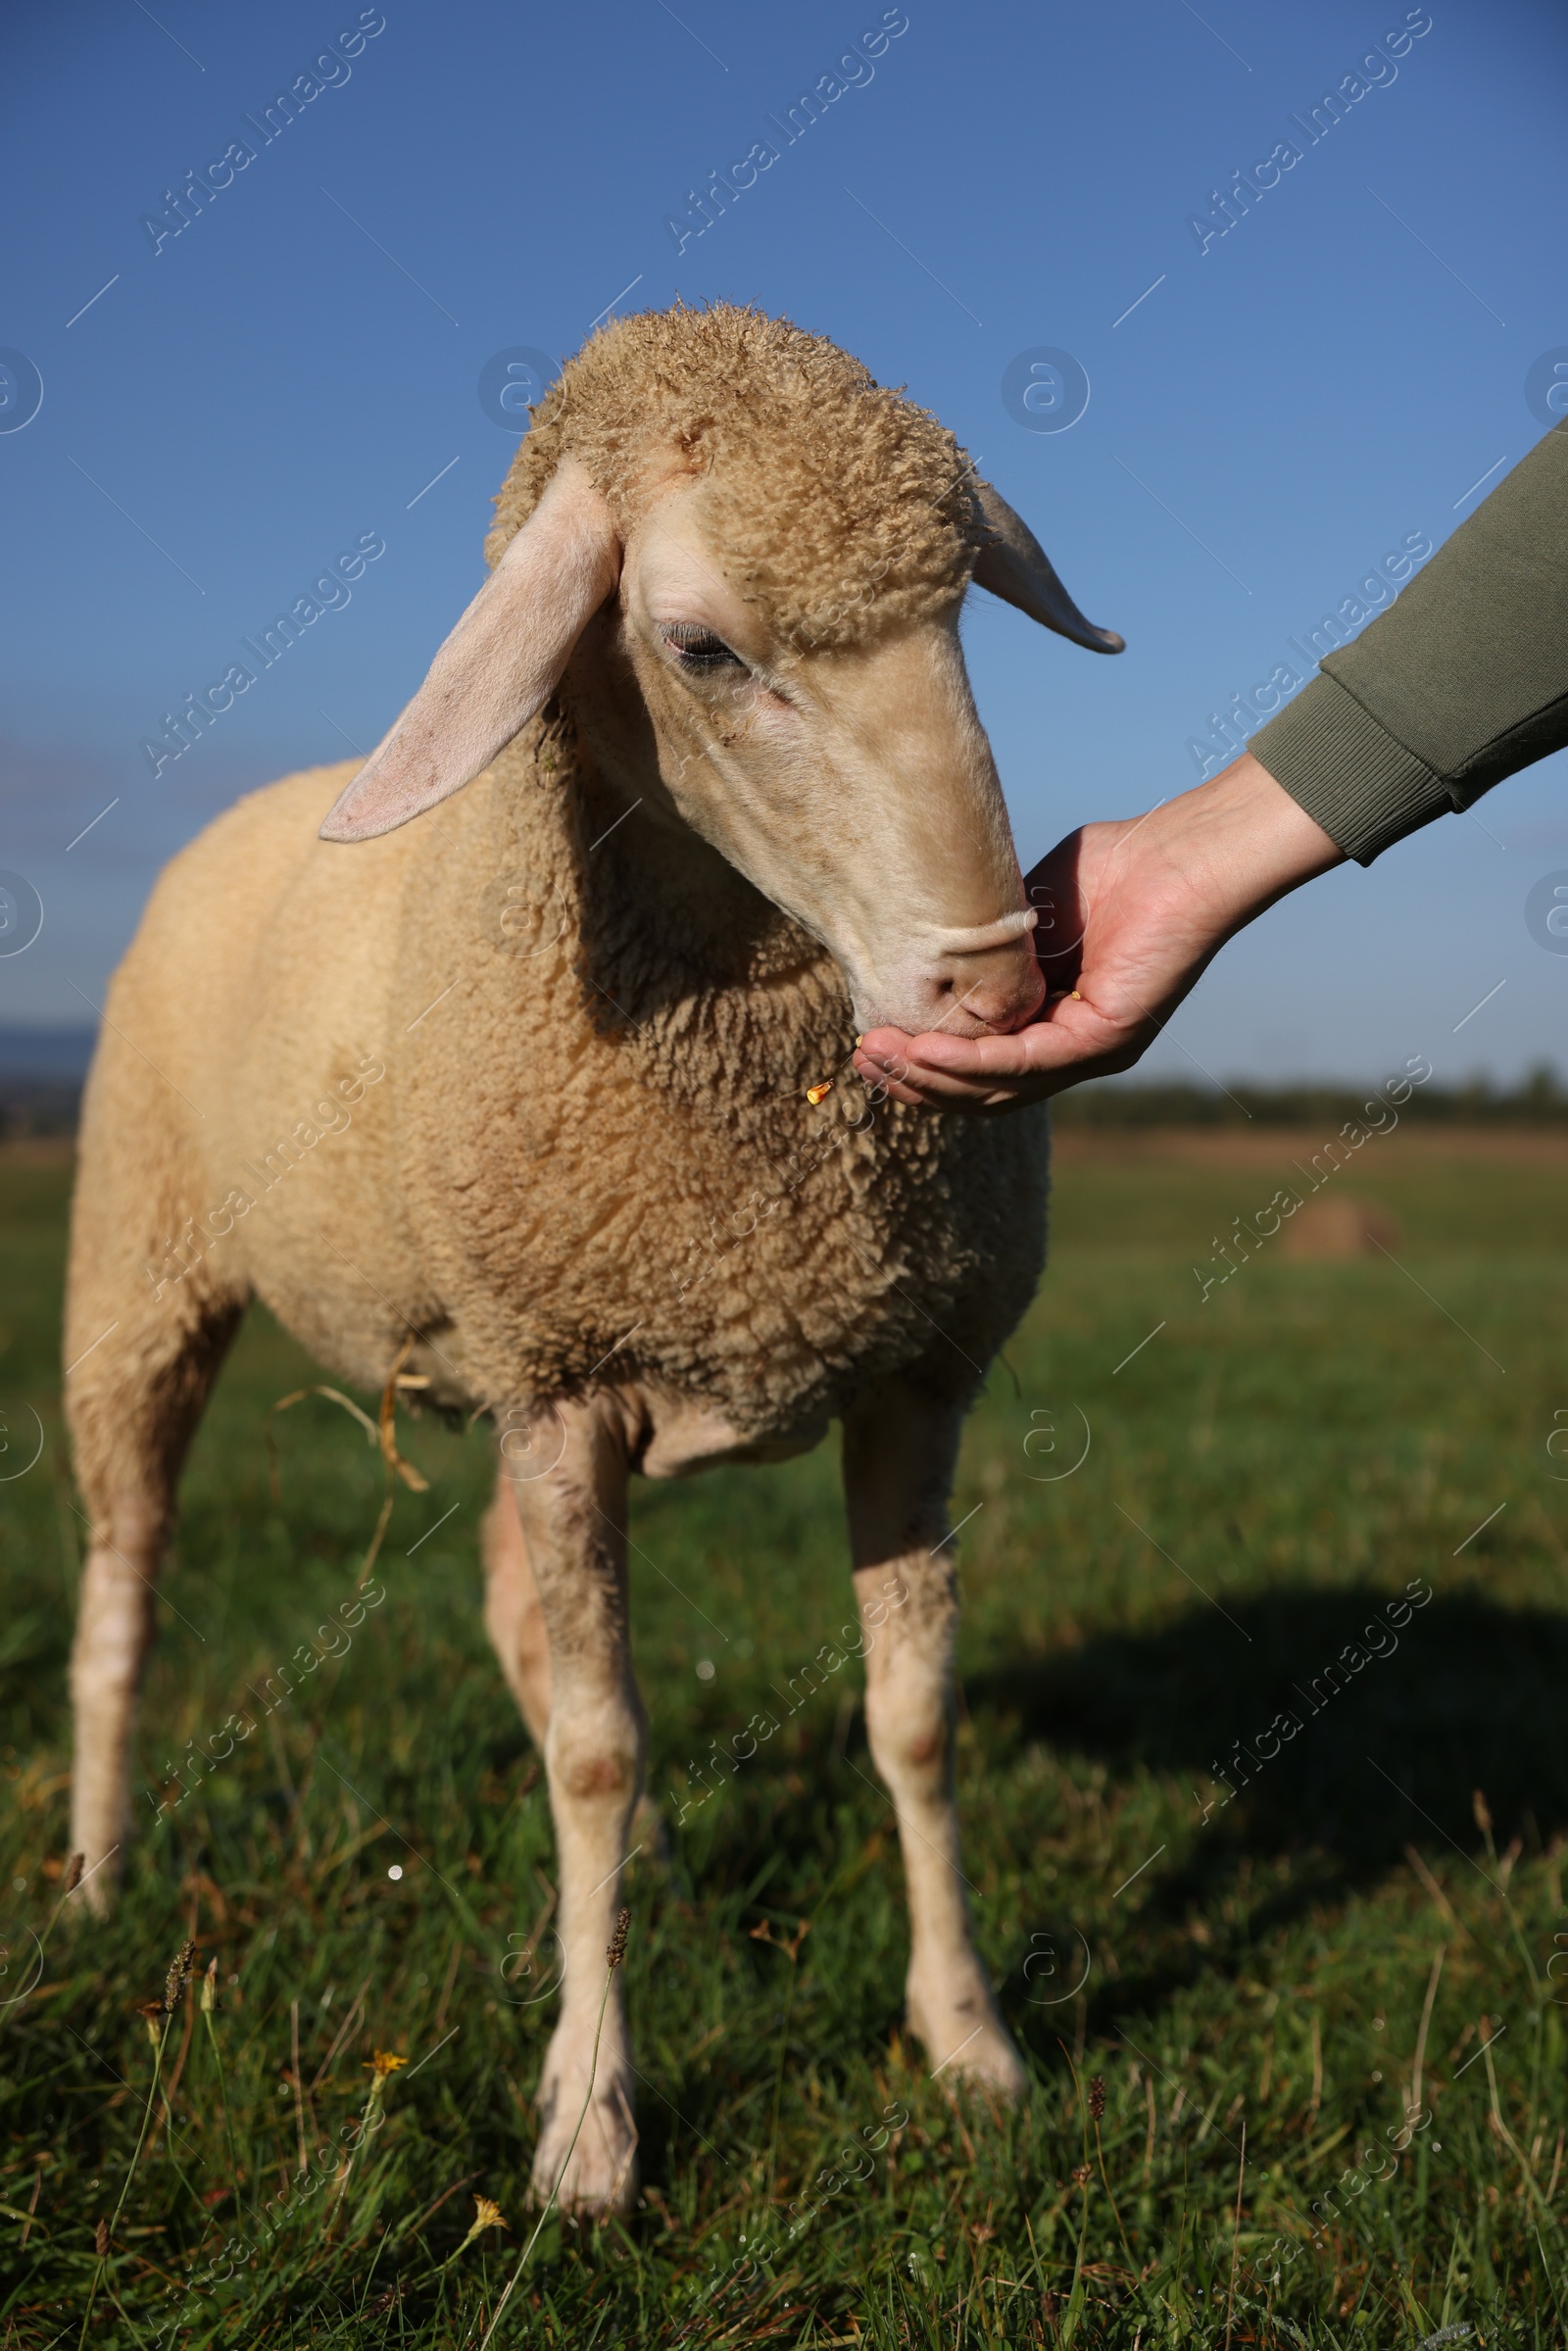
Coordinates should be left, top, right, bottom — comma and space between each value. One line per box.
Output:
484, 303, 985, 647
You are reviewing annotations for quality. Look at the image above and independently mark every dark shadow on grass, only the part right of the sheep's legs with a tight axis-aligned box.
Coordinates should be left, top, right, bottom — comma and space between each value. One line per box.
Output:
964, 1587, 1568, 2027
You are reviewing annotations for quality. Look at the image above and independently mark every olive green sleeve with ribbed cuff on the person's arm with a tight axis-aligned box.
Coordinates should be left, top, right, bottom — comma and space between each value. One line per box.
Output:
1249, 418, 1568, 865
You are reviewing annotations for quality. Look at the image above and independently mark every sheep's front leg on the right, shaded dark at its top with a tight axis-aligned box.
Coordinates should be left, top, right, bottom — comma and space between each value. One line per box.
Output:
844, 1380, 1025, 2097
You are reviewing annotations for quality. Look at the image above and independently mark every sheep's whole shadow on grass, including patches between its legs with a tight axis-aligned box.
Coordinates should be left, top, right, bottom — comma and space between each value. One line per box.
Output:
620, 1587, 1568, 2067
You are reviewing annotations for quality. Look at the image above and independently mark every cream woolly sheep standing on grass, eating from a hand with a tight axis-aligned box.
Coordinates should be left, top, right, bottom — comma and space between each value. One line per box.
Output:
66, 308, 1121, 2212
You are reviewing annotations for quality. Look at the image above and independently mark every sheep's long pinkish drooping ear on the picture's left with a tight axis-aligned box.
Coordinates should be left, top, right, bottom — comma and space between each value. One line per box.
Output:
322, 459, 620, 842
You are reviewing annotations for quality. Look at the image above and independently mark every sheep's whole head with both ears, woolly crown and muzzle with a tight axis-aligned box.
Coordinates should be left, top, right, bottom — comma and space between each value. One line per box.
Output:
322, 308, 1121, 1035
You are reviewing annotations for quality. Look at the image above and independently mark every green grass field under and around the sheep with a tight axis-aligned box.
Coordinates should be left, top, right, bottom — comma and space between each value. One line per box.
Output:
0, 1138, 1568, 2351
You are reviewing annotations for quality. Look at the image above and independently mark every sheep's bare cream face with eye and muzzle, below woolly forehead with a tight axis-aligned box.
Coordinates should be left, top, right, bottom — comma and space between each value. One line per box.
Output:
594, 482, 1044, 1035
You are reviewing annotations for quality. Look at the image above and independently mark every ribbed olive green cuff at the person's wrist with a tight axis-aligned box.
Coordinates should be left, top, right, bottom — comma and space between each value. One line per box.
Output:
1246, 672, 1452, 865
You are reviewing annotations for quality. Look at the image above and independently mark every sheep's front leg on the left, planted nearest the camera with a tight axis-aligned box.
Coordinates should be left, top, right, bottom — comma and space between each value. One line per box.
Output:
501, 1403, 647, 2212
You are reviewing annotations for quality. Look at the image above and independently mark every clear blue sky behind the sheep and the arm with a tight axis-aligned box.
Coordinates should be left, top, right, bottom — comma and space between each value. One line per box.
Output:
0, 0, 1568, 1079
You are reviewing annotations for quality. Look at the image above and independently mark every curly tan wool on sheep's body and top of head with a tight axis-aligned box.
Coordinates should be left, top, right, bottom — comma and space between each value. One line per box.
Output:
69, 311, 1049, 1507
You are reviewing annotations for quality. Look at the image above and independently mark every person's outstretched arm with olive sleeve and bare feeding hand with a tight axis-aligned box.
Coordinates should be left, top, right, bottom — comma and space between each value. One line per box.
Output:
856, 423, 1568, 1109
